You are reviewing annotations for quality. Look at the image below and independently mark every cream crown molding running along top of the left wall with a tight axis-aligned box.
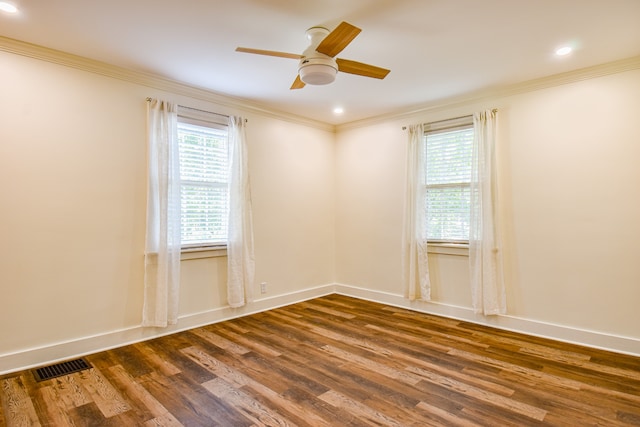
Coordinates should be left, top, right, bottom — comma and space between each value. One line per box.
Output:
0, 36, 335, 133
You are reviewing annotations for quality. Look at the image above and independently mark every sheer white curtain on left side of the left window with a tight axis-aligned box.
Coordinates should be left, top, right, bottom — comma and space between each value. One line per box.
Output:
142, 99, 180, 327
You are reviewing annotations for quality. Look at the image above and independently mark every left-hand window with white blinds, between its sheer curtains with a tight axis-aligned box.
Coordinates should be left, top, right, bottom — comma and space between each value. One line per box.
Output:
178, 114, 229, 248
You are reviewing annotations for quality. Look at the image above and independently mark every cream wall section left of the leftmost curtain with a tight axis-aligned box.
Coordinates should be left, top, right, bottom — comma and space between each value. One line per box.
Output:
0, 53, 148, 353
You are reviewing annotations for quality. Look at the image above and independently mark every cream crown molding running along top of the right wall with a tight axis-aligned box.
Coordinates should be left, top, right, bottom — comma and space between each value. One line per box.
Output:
336, 56, 640, 132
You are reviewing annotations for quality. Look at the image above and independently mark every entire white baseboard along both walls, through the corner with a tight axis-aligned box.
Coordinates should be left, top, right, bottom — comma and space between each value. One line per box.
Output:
0, 284, 640, 375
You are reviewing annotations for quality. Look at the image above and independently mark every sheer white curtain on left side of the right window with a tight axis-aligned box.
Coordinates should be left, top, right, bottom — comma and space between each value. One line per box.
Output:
402, 124, 431, 301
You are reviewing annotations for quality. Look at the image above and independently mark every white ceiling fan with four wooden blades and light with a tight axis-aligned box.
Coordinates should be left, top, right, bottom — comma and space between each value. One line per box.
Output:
236, 22, 390, 89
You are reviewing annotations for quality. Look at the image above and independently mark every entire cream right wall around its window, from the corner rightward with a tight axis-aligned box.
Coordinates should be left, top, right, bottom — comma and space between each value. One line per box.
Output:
336, 70, 640, 353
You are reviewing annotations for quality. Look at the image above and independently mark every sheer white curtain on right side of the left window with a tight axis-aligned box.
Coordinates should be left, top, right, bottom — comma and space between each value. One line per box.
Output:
227, 117, 255, 307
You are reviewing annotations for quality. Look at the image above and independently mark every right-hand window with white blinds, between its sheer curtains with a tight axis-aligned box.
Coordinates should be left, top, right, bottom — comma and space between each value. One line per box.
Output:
425, 117, 473, 243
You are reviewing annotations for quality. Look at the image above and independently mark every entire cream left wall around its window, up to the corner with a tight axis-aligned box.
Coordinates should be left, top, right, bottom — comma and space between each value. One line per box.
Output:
0, 52, 335, 372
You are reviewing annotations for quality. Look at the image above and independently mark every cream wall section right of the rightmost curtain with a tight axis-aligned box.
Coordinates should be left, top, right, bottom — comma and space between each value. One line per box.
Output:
503, 71, 640, 338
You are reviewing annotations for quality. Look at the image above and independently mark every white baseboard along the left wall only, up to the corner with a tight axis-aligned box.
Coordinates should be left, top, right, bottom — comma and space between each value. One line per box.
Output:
0, 284, 335, 375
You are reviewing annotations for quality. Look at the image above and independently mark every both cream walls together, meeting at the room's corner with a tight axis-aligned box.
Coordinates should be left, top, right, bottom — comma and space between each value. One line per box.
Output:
0, 46, 640, 372
